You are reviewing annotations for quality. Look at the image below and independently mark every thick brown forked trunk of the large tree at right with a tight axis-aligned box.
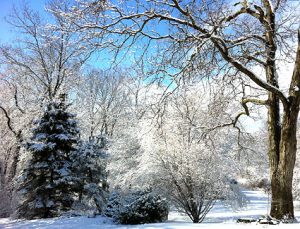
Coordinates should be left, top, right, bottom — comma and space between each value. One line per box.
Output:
268, 30, 300, 219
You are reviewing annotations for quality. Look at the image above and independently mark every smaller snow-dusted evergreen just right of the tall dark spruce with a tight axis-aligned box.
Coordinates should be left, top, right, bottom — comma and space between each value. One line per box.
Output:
72, 136, 108, 214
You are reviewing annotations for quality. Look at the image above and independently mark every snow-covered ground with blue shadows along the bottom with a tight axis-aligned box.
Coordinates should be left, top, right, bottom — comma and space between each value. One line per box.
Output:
0, 191, 300, 229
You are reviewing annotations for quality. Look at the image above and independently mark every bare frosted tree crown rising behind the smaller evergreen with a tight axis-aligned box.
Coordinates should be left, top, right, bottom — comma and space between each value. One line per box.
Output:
75, 69, 129, 138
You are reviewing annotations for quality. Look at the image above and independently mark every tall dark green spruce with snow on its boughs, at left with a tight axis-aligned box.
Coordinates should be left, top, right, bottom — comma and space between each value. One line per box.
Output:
17, 95, 79, 219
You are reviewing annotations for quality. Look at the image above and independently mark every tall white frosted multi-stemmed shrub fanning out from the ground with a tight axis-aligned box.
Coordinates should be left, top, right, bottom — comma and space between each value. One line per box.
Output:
137, 84, 245, 223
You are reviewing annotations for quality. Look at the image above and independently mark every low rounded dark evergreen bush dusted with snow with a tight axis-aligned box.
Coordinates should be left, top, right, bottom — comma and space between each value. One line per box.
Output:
106, 189, 169, 224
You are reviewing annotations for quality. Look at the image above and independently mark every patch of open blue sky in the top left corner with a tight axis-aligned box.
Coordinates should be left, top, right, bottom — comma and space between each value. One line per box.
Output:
0, 0, 48, 43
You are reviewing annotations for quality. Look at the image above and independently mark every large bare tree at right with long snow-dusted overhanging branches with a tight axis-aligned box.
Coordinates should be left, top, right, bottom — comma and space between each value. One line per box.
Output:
52, 0, 300, 219
